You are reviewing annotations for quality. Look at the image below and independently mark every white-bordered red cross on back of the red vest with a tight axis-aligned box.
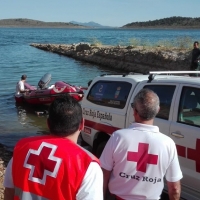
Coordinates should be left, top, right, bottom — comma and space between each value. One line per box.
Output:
24, 142, 62, 185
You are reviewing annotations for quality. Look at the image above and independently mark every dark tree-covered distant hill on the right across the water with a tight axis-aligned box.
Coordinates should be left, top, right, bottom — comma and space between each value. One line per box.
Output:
122, 17, 200, 28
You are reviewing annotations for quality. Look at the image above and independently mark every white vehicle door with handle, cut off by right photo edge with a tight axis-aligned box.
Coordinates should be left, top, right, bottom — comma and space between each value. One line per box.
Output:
170, 84, 200, 199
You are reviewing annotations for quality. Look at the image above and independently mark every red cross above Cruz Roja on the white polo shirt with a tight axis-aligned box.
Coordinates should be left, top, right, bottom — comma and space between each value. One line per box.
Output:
127, 143, 158, 172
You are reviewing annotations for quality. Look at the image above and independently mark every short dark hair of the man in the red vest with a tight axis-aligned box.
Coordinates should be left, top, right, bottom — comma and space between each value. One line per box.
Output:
48, 94, 83, 136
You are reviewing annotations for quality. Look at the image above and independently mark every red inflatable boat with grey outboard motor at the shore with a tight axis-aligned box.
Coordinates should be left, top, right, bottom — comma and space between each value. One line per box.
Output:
15, 73, 87, 105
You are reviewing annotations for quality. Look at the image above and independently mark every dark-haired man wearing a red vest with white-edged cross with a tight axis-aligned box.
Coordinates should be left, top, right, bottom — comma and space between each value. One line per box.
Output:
4, 95, 103, 200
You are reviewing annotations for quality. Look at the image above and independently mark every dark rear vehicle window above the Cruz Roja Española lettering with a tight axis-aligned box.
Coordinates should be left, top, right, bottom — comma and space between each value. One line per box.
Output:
87, 81, 132, 109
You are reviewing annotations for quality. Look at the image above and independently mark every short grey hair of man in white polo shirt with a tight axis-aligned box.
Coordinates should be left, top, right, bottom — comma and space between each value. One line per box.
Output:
132, 88, 160, 120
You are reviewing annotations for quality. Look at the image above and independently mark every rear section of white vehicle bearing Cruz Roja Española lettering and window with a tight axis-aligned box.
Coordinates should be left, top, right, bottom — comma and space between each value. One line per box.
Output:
81, 77, 133, 146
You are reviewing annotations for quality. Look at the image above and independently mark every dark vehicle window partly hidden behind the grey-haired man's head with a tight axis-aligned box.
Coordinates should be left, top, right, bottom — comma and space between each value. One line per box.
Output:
144, 85, 176, 120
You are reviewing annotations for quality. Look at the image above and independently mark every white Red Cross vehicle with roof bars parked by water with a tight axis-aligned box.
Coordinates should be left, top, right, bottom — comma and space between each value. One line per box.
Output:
81, 71, 200, 200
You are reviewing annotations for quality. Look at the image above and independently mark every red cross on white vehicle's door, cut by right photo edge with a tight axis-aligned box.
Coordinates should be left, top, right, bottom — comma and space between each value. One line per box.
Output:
187, 139, 200, 173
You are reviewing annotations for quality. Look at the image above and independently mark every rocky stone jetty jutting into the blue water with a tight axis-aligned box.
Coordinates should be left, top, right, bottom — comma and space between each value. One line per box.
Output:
30, 43, 191, 74
